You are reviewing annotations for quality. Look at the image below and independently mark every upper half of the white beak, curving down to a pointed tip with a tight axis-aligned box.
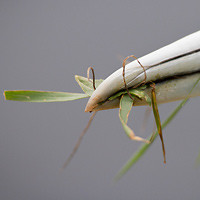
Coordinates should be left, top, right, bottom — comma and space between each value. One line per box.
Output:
85, 31, 200, 112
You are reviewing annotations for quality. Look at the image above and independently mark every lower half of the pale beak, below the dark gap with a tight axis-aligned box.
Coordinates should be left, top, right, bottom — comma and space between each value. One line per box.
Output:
93, 73, 200, 111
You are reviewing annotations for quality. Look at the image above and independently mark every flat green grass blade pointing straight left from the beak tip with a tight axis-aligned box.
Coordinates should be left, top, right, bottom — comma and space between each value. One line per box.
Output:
4, 90, 89, 102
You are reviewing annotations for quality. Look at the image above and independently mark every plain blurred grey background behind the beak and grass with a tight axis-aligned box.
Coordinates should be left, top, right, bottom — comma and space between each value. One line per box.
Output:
0, 0, 200, 200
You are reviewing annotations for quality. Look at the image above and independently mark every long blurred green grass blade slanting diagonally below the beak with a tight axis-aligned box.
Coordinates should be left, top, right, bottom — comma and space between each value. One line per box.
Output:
115, 78, 200, 181
